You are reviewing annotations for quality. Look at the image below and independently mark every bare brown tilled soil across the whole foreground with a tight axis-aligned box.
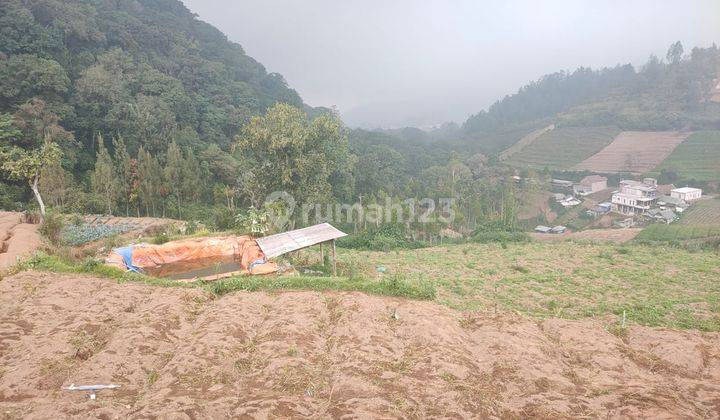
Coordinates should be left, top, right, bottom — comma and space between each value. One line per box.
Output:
0, 272, 720, 418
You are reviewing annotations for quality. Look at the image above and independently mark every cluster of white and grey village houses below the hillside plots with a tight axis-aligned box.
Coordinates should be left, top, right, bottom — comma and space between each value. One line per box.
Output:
535, 175, 703, 234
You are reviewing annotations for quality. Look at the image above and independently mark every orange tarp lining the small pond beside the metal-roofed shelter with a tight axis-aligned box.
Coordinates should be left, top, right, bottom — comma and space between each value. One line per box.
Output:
106, 236, 278, 274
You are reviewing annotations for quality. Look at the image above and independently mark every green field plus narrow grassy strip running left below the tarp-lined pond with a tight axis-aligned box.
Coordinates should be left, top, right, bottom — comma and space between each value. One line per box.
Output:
18, 242, 720, 331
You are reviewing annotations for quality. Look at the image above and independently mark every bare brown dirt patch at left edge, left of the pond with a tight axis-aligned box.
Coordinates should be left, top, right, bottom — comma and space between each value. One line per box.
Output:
0, 212, 42, 271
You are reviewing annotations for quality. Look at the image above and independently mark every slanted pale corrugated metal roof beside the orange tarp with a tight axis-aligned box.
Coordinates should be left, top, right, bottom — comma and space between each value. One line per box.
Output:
256, 223, 347, 258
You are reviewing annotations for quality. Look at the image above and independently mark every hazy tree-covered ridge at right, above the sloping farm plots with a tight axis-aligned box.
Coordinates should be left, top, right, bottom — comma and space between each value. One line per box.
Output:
463, 42, 720, 154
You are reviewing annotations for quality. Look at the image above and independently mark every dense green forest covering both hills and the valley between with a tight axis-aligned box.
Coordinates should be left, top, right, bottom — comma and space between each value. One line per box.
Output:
0, 0, 720, 243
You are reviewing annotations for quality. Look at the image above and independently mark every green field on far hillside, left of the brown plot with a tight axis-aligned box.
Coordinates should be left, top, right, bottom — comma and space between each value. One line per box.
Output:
506, 127, 620, 169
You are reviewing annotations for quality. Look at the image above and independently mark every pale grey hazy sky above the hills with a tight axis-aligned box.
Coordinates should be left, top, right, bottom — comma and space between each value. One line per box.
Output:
183, 0, 720, 127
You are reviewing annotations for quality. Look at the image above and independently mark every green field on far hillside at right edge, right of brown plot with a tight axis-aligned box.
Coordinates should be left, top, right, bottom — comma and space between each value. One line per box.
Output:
653, 131, 720, 181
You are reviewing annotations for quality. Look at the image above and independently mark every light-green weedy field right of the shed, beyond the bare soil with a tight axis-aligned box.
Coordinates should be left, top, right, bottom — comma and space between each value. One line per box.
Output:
341, 242, 720, 331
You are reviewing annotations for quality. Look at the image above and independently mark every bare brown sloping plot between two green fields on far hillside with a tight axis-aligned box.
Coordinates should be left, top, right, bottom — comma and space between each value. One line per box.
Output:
575, 131, 692, 174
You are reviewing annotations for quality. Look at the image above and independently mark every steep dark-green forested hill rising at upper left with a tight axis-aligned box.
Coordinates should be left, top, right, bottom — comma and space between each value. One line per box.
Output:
0, 0, 303, 164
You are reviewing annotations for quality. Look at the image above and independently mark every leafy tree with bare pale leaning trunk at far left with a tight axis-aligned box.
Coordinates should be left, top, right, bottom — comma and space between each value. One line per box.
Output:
0, 99, 74, 217
